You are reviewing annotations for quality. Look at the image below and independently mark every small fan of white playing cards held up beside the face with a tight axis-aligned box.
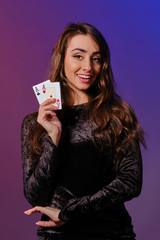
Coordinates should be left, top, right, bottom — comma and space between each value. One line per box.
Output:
33, 80, 62, 109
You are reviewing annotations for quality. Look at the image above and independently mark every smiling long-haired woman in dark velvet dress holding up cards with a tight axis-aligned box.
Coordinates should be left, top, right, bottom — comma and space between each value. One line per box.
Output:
22, 23, 145, 240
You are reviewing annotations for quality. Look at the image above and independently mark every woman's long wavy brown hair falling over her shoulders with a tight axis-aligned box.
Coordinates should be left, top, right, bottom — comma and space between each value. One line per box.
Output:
28, 23, 146, 166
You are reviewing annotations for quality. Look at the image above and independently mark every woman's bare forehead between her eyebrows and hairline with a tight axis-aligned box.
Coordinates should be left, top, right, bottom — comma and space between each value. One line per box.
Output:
66, 34, 100, 52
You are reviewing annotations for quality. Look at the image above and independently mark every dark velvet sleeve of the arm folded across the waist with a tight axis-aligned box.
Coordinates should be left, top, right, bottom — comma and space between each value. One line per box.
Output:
59, 144, 142, 222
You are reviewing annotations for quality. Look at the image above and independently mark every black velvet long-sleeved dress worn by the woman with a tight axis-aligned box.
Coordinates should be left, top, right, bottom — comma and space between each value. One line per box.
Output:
22, 104, 142, 240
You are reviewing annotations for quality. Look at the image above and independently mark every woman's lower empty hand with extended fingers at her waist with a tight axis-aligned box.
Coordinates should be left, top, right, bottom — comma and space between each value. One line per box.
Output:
24, 206, 64, 227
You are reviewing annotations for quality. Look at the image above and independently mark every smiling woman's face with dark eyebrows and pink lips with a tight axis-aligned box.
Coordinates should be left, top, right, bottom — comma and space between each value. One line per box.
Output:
64, 34, 101, 94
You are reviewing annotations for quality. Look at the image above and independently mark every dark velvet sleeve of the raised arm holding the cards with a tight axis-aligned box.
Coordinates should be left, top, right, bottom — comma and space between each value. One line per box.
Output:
21, 115, 57, 206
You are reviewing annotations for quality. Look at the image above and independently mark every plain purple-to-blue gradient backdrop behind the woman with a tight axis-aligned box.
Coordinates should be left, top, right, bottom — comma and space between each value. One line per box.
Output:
0, 0, 160, 240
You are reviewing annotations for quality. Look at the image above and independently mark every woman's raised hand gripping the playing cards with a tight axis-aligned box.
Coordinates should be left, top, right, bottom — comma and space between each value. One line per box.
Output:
37, 99, 62, 146
